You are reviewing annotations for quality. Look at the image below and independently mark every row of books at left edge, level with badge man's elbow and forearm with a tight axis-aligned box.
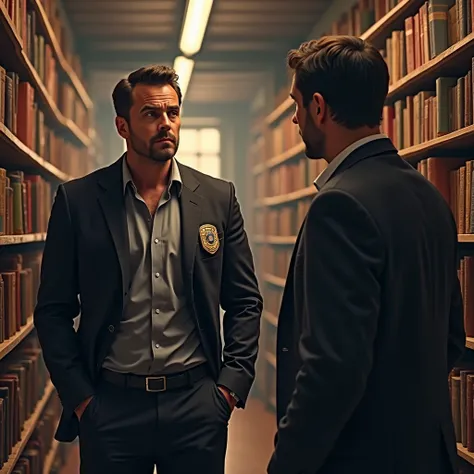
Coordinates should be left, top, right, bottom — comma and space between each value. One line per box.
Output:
0, 250, 42, 343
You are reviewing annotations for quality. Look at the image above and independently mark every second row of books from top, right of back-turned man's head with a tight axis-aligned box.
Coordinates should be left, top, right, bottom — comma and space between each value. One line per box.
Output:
382, 67, 474, 150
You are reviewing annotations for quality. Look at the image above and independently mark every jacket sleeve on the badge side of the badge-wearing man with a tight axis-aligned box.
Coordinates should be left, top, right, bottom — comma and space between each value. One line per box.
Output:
217, 183, 263, 408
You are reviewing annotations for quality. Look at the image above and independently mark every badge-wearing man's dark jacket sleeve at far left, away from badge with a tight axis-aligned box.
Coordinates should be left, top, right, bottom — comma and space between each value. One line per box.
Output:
34, 185, 93, 414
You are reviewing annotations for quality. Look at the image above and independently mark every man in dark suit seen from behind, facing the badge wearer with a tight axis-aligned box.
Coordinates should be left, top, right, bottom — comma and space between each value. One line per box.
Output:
268, 36, 465, 474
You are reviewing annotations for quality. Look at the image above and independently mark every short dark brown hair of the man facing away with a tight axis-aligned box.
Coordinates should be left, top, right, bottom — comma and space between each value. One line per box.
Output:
288, 36, 389, 129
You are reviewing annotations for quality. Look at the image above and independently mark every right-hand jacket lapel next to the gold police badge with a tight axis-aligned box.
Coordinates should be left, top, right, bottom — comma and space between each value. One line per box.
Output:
178, 163, 202, 290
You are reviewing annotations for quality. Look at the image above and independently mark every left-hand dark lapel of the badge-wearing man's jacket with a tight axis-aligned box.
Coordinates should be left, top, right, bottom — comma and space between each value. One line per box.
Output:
98, 155, 130, 294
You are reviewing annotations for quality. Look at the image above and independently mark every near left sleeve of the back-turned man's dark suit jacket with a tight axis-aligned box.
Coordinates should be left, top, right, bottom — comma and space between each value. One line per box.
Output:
268, 190, 385, 474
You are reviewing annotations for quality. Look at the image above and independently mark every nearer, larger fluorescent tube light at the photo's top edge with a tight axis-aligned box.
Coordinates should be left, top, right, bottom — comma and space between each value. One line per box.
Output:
179, 0, 213, 56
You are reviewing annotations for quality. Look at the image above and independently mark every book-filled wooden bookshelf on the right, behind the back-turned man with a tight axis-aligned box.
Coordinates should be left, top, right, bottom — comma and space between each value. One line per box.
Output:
248, 0, 474, 465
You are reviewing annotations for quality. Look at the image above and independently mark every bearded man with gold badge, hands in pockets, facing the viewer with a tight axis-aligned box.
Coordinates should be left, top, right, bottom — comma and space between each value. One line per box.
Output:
35, 66, 262, 474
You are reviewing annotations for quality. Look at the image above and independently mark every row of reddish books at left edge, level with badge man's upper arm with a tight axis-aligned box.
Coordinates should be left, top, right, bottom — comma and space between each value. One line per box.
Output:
0, 168, 52, 235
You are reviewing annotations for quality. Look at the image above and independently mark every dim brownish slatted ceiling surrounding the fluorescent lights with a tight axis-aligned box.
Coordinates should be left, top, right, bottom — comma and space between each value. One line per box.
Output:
63, 0, 330, 105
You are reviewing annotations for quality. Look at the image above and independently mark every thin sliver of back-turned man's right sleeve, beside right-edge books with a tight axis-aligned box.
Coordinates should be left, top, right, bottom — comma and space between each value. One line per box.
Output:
448, 252, 466, 373
